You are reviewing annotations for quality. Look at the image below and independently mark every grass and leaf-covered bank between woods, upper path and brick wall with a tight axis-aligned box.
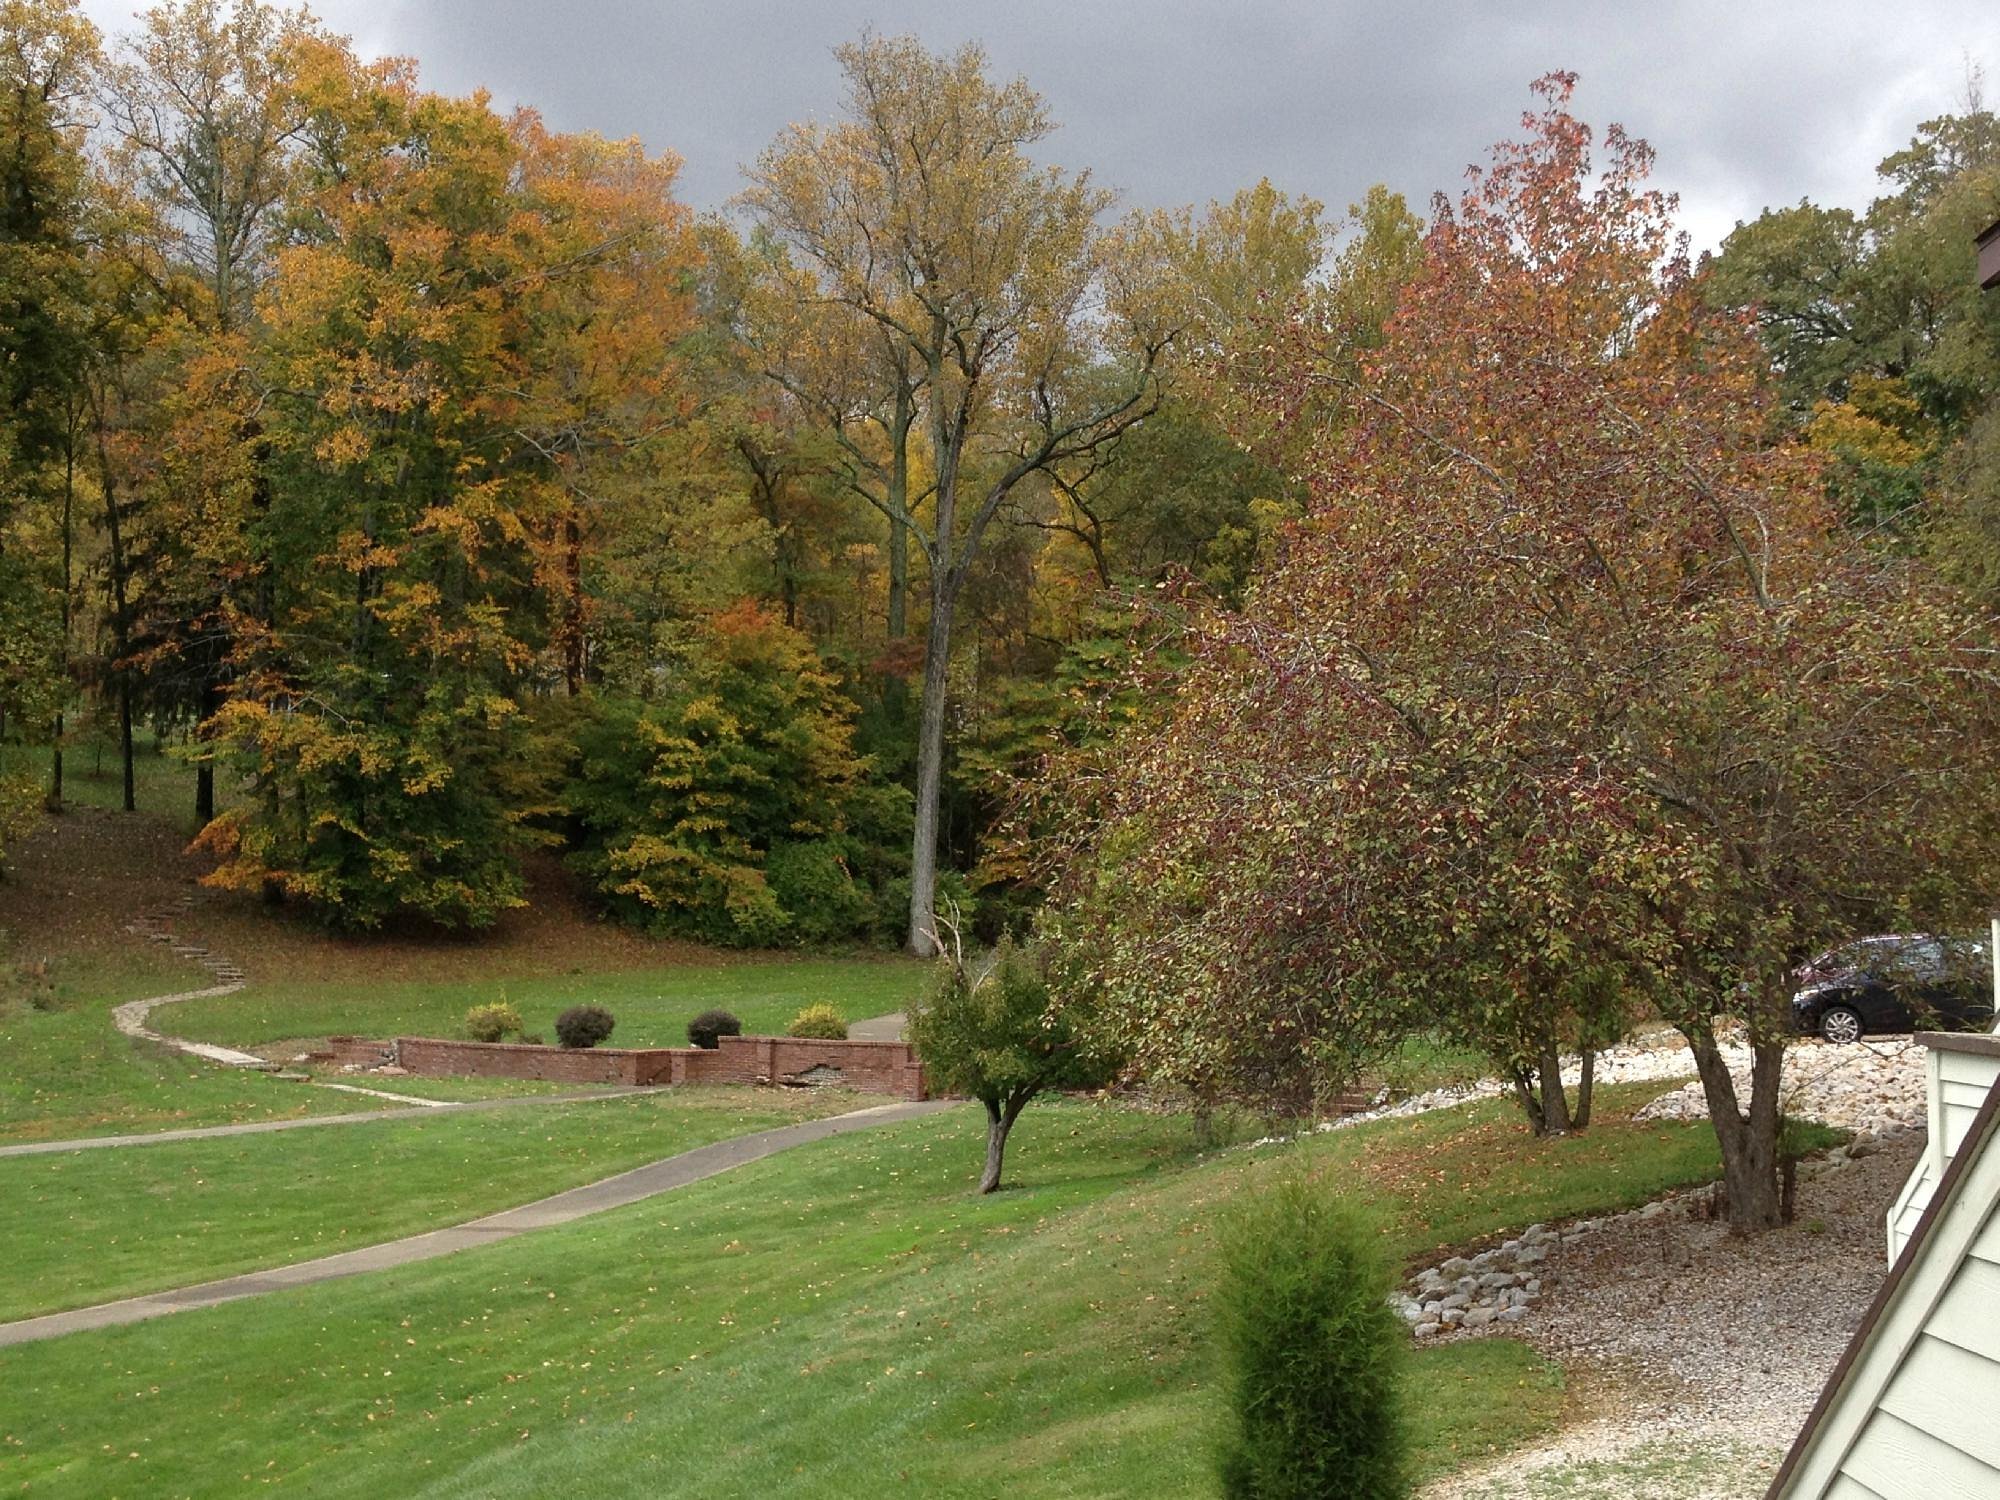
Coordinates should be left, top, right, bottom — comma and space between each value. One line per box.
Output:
0, 768, 920, 1142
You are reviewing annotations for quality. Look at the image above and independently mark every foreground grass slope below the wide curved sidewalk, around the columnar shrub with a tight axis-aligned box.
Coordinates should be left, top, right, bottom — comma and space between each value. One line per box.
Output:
0, 1100, 1714, 1498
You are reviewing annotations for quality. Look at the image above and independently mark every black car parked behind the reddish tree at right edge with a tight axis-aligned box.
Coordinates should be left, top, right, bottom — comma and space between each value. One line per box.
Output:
1792, 934, 1994, 1042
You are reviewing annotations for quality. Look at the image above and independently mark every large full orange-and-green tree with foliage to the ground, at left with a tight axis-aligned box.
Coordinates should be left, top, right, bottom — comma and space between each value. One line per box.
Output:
204, 44, 550, 926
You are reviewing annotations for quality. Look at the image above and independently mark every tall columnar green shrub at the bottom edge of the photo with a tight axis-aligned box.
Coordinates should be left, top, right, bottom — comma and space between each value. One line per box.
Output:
1214, 1178, 1410, 1500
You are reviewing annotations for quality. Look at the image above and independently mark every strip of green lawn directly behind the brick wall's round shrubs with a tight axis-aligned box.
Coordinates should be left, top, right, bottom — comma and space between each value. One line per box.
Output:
174, 954, 926, 1046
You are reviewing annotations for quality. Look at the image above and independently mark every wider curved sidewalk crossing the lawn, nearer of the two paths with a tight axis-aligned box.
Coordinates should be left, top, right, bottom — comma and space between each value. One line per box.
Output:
0, 1100, 954, 1348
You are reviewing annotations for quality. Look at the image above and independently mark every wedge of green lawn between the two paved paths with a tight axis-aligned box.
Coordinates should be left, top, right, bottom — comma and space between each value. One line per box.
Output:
0, 1088, 880, 1322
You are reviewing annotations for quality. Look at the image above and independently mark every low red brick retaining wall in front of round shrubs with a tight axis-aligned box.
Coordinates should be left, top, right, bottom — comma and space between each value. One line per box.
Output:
382, 1036, 928, 1100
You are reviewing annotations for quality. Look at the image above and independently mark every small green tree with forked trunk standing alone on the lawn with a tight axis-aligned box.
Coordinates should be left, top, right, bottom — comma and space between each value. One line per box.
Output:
910, 916, 1116, 1192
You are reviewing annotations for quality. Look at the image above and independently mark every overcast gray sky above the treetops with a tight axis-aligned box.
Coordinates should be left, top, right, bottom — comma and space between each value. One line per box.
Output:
86, 0, 2000, 248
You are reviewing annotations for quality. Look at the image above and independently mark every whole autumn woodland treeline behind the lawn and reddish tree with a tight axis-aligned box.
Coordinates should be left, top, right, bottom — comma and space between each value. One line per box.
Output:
0, 0, 2000, 976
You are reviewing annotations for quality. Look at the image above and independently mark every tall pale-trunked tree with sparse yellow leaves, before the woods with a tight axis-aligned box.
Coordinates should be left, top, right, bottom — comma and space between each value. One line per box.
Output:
744, 38, 1172, 954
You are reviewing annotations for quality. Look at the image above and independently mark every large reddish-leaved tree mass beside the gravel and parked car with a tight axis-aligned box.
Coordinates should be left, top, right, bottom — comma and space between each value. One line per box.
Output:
1074, 74, 2000, 1230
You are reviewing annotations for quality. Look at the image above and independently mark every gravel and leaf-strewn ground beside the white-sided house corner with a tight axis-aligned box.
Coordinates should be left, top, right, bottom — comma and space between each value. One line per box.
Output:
1424, 1132, 1924, 1500
